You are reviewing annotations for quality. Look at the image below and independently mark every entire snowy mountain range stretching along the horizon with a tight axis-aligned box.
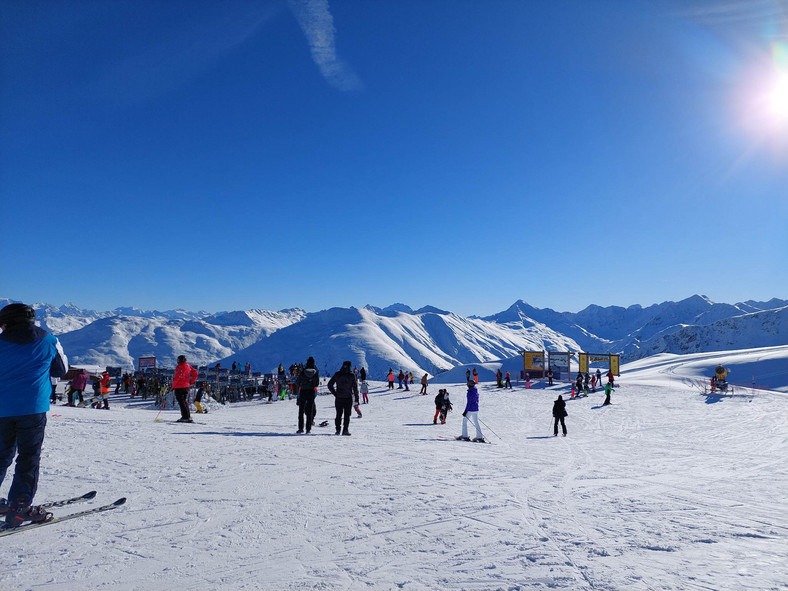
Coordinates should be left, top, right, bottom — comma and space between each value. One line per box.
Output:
0, 295, 788, 376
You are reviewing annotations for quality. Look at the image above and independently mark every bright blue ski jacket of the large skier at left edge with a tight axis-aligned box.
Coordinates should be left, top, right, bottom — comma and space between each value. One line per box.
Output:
0, 323, 68, 417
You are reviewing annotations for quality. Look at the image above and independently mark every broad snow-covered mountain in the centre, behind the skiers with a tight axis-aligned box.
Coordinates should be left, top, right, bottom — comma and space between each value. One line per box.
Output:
215, 307, 578, 379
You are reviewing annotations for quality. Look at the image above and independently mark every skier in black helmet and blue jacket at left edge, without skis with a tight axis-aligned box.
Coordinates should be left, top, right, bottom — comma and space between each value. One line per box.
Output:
0, 304, 68, 527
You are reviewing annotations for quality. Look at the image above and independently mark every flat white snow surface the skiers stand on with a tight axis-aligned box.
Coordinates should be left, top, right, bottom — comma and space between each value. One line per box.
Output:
0, 347, 788, 591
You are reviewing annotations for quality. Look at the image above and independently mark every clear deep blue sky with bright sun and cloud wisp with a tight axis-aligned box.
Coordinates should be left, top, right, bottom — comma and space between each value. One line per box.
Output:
0, 0, 788, 315
